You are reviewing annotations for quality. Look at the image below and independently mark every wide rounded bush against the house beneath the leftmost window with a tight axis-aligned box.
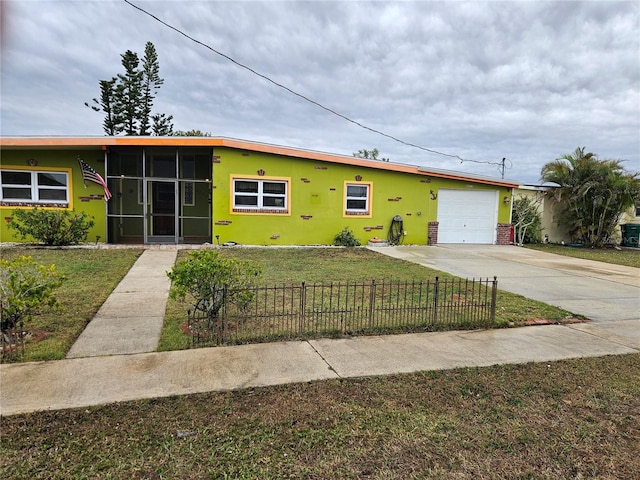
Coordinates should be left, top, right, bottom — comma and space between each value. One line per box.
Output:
8, 207, 95, 246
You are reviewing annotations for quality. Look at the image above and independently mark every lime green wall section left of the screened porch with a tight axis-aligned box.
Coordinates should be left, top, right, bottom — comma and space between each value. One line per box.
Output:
0, 149, 107, 242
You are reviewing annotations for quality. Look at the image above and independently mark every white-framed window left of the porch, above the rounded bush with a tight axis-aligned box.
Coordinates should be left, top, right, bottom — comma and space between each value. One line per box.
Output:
0, 170, 69, 205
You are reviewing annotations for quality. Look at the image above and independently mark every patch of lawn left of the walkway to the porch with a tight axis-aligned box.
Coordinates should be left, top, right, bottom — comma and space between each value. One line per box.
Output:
0, 247, 142, 361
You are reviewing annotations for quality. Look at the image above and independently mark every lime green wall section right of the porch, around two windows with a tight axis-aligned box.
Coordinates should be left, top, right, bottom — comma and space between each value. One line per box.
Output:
213, 148, 511, 245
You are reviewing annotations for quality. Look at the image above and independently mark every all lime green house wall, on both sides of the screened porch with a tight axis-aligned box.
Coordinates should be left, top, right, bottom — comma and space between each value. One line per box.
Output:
0, 148, 511, 245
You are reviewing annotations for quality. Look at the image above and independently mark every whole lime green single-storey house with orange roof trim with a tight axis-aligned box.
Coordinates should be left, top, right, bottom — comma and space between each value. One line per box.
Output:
0, 137, 517, 245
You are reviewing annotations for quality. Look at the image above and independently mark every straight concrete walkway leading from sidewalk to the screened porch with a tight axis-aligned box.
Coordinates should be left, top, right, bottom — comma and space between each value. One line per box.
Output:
67, 248, 177, 358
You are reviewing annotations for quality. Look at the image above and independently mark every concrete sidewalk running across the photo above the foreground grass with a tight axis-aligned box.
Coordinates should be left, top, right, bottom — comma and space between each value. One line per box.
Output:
0, 321, 640, 415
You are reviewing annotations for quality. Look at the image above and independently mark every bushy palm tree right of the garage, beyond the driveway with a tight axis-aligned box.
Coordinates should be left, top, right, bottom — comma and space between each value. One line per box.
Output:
540, 147, 640, 247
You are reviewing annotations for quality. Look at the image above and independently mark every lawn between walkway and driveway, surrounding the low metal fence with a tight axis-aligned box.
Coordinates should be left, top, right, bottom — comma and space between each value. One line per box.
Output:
159, 248, 570, 351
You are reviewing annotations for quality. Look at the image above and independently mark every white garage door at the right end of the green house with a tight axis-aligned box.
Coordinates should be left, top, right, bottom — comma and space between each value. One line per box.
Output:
438, 190, 498, 244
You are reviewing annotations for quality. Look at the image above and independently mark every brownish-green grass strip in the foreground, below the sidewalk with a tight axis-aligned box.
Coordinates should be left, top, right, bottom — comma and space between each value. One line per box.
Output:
0, 355, 640, 479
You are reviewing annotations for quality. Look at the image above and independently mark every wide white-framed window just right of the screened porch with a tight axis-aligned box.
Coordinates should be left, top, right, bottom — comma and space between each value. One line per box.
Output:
233, 178, 288, 213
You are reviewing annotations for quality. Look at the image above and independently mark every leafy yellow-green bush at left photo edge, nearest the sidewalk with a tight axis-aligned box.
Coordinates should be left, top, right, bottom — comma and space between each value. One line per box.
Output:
0, 255, 65, 331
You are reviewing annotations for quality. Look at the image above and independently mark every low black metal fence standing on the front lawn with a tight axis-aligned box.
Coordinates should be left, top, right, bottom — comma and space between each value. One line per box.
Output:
187, 277, 498, 345
